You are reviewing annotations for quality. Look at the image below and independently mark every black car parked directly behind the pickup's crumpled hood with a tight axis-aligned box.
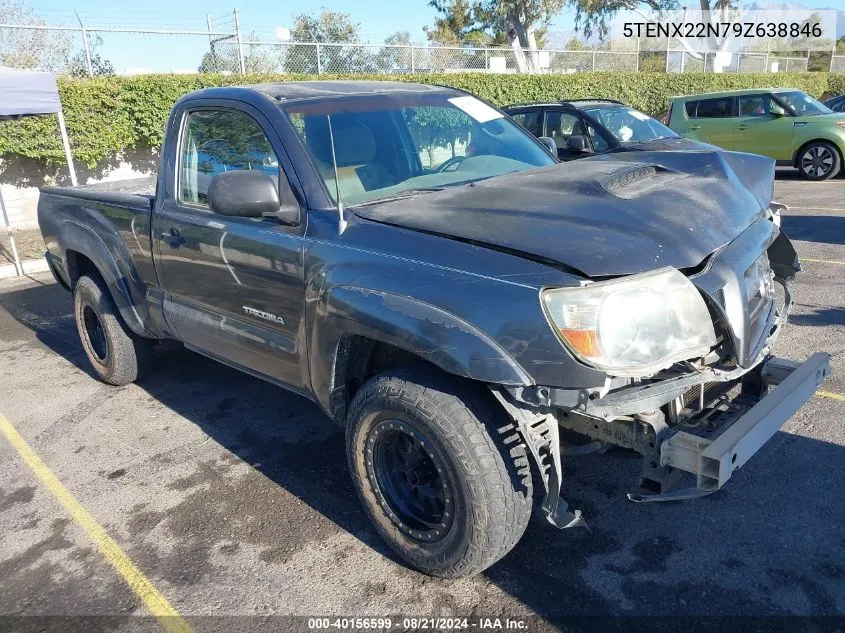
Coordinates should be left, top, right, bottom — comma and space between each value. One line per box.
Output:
502, 99, 713, 161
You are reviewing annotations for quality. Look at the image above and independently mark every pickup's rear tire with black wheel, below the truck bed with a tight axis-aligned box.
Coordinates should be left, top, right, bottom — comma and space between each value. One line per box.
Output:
73, 275, 153, 385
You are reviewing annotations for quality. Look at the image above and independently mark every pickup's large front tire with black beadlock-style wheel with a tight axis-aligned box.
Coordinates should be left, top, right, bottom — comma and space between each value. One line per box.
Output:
346, 366, 533, 578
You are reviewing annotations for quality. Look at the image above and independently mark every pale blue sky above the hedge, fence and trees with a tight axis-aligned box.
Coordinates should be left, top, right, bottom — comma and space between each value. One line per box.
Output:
14, 0, 843, 73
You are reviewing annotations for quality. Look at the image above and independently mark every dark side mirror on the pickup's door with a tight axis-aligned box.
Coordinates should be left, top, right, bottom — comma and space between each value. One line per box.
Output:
208, 169, 300, 225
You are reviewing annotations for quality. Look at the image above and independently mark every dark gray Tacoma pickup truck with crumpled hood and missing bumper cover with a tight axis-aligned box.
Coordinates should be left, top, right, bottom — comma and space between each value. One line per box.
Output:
38, 82, 829, 578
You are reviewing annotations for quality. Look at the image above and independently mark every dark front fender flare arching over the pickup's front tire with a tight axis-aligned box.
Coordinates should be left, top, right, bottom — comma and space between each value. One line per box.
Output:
310, 286, 533, 410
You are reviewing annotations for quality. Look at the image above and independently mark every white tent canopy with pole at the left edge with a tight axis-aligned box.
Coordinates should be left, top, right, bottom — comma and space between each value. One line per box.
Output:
0, 66, 76, 275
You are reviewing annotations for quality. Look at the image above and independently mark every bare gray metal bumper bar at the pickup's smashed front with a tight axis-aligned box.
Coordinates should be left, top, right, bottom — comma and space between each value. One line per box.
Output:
648, 352, 830, 501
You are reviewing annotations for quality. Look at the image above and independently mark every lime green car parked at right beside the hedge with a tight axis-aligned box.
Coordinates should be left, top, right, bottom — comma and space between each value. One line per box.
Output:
665, 88, 845, 180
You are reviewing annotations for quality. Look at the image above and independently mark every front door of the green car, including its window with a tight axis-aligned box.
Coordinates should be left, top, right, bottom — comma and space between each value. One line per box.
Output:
733, 94, 795, 160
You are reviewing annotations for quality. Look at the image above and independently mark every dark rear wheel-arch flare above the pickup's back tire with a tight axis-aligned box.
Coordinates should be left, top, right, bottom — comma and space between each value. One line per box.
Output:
58, 221, 155, 338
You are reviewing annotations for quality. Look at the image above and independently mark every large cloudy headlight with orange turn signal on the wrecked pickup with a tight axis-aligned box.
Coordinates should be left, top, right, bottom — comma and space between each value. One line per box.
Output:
541, 268, 716, 376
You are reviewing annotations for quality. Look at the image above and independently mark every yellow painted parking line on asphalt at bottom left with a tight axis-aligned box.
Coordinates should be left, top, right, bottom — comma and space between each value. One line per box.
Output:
0, 414, 193, 633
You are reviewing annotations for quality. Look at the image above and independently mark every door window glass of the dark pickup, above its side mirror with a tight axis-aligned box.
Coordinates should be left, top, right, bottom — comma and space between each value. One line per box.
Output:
179, 110, 279, 207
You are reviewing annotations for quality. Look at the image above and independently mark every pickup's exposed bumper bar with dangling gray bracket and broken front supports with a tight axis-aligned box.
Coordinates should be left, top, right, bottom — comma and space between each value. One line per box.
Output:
493, 352, 830, 528
